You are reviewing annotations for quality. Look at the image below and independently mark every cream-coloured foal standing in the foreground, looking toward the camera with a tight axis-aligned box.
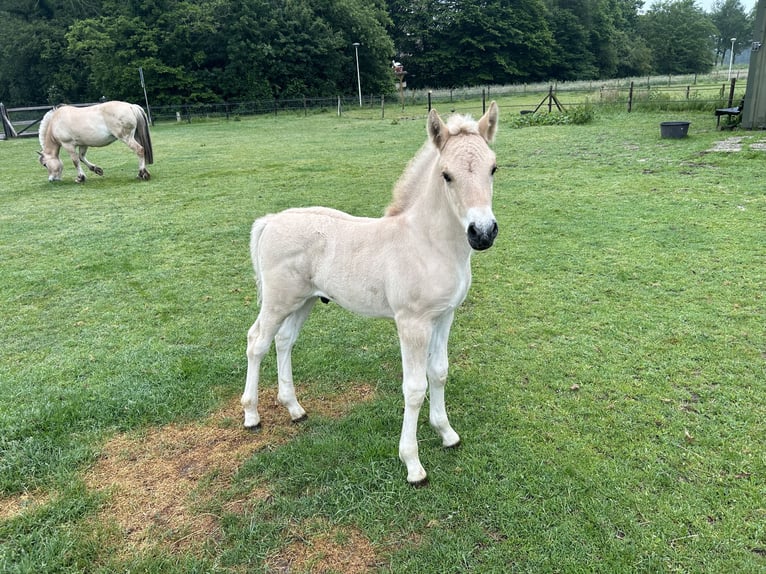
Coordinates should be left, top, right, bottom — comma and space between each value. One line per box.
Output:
242, 102, 498, 484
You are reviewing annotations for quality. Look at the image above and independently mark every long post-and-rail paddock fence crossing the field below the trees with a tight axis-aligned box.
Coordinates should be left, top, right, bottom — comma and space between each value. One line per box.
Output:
0, 70, 747, 139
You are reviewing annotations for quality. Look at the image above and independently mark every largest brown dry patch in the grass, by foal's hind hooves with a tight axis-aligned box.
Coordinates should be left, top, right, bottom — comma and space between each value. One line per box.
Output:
85, 385, 374, 552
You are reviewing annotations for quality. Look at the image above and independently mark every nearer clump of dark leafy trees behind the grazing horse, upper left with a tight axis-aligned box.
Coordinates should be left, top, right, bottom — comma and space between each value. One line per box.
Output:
0, 0, 394, 104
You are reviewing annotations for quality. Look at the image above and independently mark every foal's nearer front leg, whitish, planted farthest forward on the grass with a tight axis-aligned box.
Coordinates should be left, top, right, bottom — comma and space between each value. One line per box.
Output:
396, 318, 431, 484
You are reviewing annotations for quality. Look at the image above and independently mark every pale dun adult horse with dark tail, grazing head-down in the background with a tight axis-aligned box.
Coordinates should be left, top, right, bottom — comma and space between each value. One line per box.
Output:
37, 101, 154, 183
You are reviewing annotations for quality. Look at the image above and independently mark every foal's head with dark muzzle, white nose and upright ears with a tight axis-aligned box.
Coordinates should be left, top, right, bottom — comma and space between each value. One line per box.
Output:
428, 102, 498, 251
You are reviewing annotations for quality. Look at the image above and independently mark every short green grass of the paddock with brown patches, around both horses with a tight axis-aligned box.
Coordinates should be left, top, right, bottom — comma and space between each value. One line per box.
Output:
0, 102, 766, 573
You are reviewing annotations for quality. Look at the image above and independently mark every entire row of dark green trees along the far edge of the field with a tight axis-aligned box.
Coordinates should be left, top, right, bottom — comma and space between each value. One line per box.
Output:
0, 0, 754, 105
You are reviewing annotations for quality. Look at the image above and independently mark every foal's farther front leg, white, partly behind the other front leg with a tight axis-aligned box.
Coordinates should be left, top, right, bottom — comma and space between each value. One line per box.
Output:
428, 313, 460, 447
